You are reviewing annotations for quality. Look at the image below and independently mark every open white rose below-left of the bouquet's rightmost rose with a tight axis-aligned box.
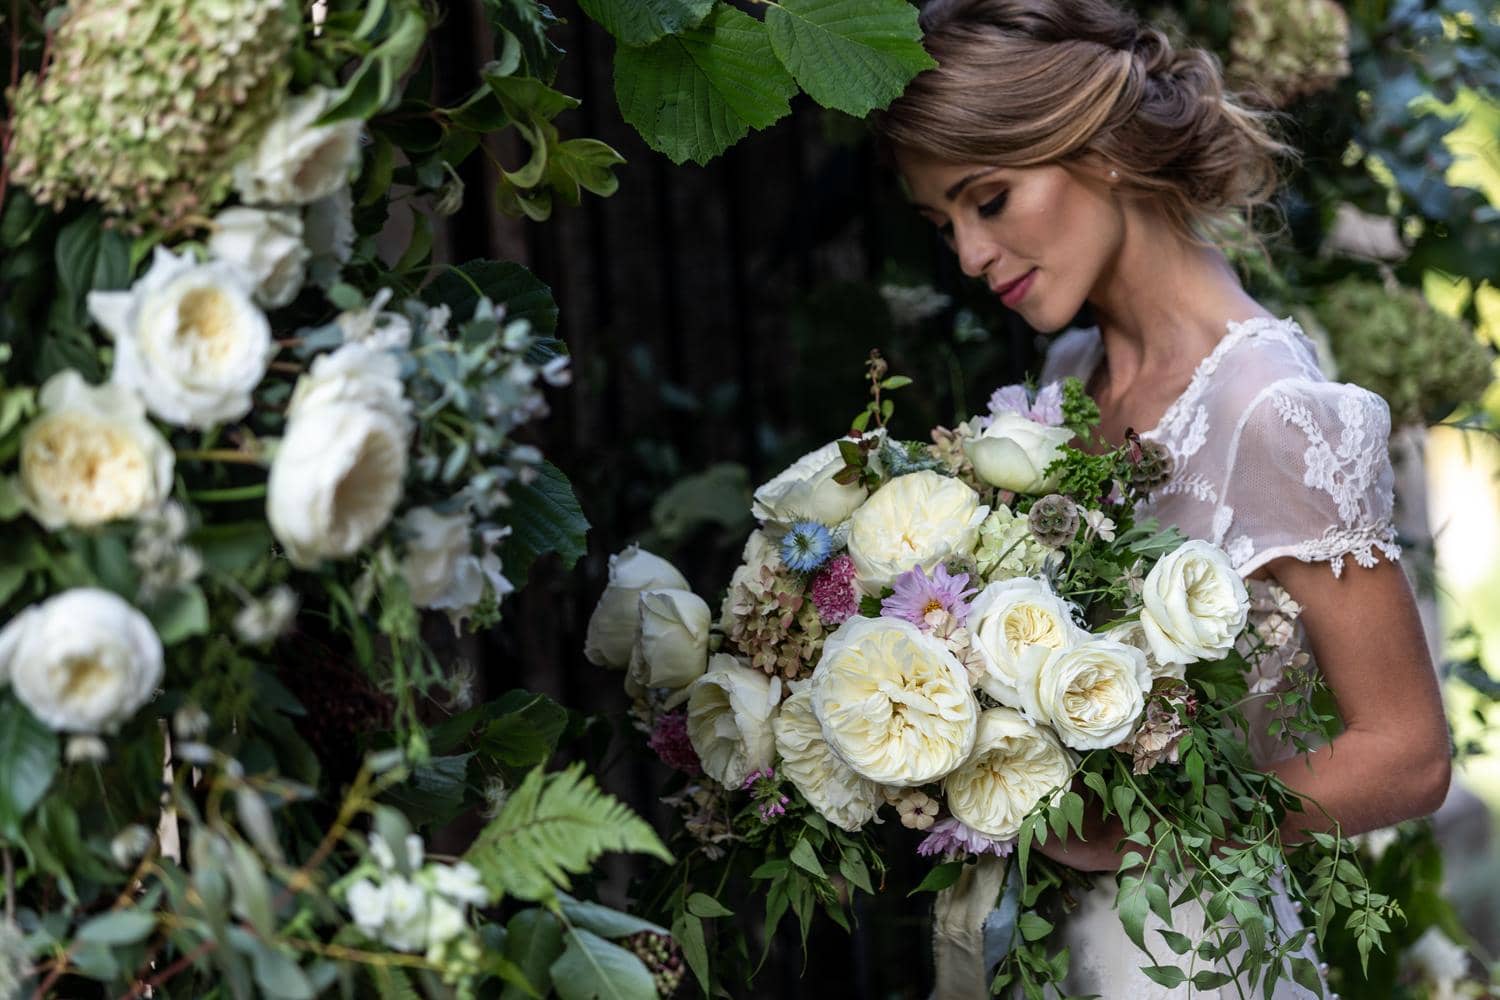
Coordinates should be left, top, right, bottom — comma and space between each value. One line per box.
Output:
1022, 639, 1151, 750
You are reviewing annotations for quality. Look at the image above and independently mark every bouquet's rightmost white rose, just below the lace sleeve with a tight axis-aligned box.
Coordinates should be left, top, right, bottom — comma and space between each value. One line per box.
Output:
1140, 540, 1250, 664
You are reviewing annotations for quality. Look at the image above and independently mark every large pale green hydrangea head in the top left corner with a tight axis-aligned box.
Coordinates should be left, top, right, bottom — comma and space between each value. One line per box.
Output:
11, 0, 299, 231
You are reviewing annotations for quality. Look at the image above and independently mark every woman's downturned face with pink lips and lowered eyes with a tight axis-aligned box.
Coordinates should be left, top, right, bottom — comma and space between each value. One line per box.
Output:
897, 151, 1124, 333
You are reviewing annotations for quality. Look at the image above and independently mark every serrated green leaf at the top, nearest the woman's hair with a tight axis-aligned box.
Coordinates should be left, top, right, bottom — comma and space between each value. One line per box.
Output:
765, 0, 938, 118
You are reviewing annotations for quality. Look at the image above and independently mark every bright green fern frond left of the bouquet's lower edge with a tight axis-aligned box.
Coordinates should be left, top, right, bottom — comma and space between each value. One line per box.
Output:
465, 763, 672, 900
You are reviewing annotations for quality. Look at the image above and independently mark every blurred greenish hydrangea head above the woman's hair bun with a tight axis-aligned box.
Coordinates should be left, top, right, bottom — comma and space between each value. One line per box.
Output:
1229, 0, 1349, 108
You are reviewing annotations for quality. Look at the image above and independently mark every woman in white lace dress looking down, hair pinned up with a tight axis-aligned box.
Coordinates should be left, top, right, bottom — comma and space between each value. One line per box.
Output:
876, 0, 1449, 1000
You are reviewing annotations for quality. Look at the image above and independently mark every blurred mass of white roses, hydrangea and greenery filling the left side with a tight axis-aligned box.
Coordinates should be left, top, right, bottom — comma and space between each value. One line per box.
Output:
0, 0, 683, 1000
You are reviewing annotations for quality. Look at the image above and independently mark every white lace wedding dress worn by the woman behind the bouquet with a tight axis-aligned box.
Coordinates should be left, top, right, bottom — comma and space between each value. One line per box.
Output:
1043, 319, 1401, 1000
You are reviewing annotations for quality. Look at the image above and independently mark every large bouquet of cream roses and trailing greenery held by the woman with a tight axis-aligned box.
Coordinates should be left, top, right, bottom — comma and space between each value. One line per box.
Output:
585, 355, 1391, 991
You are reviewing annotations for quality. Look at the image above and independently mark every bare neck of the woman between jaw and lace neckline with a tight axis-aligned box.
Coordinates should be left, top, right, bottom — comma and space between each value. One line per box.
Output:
1089, 211, 1268, 388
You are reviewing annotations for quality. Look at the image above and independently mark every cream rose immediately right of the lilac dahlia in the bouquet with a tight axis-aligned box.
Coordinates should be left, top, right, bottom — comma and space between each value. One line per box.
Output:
969, 577, 1089, 711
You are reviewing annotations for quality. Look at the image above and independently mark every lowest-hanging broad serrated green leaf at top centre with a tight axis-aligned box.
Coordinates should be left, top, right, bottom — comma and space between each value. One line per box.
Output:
615, 4, 797, 163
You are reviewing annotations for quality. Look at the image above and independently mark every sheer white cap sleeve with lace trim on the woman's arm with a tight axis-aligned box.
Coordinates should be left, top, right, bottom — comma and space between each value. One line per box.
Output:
1212, 378, 1401, 576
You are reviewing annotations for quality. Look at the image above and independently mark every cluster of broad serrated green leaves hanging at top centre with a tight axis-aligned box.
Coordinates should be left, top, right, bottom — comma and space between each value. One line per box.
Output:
581, 0, 933, 163
